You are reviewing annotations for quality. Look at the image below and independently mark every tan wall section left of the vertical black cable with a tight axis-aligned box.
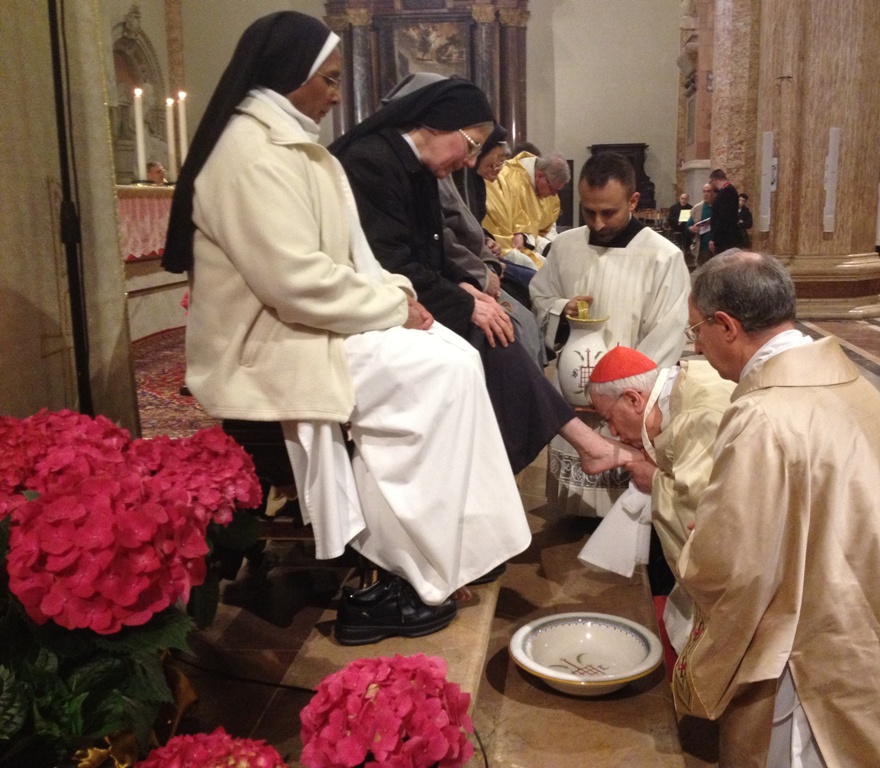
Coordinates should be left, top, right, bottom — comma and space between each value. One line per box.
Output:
0, 2, 76, 417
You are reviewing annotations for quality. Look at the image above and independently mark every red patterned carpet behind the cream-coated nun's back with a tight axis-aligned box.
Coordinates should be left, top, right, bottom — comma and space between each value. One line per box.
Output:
132, 327, 218, 437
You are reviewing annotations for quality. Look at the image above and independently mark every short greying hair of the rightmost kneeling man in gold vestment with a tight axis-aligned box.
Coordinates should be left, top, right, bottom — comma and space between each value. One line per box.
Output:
691, 248, 797, 333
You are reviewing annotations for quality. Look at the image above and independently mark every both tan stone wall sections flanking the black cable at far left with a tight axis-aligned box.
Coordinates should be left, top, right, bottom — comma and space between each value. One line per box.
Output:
0, 0, 137, 429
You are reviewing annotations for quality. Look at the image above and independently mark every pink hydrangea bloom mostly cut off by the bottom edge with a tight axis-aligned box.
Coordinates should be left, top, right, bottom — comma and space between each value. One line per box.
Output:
135, 728, 287, 768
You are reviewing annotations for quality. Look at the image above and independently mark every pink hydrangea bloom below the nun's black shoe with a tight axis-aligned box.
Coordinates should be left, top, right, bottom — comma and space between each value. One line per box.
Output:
300, 654, 474, 768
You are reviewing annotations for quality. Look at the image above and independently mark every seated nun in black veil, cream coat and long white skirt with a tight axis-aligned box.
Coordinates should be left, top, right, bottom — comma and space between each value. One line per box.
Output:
163, 11, 531, 645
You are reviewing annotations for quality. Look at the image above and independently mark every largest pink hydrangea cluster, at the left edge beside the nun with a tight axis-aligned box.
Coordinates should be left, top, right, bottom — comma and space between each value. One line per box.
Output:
0, 411, 260, 634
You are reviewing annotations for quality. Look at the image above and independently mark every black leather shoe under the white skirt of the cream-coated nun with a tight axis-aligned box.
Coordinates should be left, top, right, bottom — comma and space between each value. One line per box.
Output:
335, 573, 458, 645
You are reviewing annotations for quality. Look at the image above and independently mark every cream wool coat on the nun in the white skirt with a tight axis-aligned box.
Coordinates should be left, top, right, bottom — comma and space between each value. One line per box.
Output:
186, 97, 414, 422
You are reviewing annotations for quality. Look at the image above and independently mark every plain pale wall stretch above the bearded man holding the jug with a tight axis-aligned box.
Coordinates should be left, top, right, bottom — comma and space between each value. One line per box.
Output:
527, 0, 680, 207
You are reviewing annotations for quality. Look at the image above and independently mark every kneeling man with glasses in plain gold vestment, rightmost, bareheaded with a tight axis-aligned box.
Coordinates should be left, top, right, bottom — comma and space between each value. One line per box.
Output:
673, 251, 880, 768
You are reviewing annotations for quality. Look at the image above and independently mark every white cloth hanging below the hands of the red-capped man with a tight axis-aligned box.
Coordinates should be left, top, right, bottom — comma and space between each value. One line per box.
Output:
578, 483, 651, 577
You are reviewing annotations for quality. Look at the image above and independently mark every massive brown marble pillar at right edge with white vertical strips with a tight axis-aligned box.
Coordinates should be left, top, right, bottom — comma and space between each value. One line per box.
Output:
748, 0, 880, 317
